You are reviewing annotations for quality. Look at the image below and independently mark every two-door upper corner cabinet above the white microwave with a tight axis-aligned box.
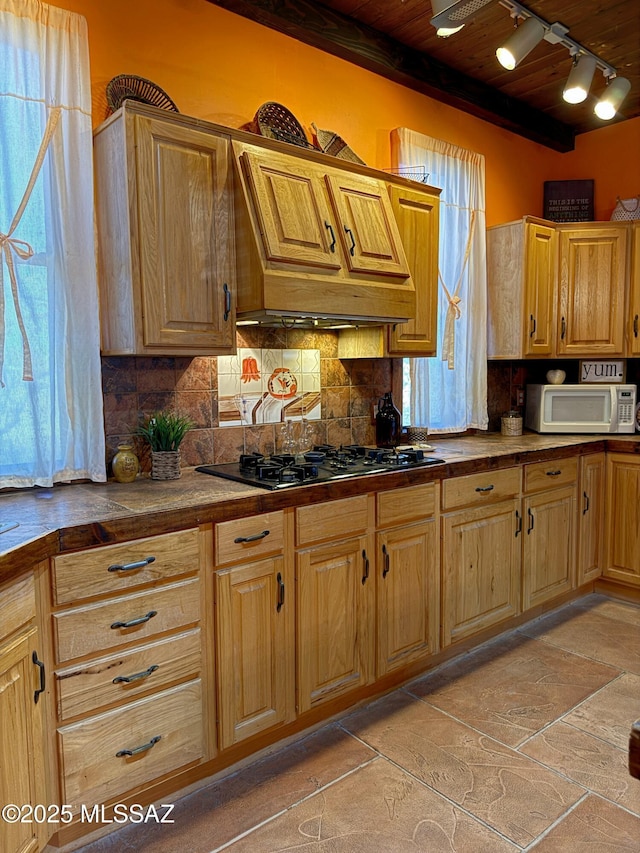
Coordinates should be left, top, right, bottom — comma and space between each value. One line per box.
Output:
487, 216, 629, 358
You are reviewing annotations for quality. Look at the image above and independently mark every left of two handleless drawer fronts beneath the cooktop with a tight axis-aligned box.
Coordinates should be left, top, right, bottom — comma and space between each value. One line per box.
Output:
296, 495, 368, 545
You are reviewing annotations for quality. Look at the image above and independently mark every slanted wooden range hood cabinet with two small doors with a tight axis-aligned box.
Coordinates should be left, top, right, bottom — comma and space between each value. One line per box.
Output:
233, 141, 416, 321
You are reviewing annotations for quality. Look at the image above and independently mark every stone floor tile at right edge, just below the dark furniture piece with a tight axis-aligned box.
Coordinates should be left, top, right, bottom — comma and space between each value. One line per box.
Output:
518, 722, 640, 816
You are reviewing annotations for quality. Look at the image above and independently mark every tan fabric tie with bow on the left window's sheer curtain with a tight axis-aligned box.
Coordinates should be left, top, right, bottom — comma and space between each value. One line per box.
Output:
0, 107, 61, 388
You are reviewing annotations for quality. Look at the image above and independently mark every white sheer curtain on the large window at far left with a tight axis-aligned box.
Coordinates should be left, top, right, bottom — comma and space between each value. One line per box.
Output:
0, 0, 106, 488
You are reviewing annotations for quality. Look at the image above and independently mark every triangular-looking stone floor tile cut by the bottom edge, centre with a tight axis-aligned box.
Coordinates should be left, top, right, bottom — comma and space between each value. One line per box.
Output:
225, 758, 518, 853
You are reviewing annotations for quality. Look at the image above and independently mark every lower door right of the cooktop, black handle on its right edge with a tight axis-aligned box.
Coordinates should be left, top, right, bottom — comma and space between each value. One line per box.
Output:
442, 499, 522, 646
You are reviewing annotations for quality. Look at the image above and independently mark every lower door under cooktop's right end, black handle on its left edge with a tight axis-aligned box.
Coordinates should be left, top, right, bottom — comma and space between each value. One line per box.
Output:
376, 519, 440, 678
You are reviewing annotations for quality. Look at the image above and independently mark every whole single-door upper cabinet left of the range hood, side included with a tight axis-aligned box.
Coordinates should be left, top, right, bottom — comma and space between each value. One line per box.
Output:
94, 101, 235, 355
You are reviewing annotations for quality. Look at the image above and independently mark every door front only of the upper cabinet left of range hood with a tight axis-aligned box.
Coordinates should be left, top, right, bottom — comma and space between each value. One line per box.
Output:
135, 116, 235, 351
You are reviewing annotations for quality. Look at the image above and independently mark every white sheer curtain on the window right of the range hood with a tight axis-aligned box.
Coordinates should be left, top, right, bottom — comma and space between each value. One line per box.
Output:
391, 128, 488, 433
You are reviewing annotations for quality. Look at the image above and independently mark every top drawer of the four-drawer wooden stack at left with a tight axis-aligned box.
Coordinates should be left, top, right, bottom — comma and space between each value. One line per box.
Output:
52, 528, 199, 604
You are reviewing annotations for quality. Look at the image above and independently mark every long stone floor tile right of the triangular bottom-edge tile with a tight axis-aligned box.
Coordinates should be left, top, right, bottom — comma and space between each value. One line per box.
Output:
342, 692, 585, 847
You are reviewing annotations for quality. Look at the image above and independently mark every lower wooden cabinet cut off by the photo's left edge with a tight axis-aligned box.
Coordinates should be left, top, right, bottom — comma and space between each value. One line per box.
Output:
0, 573, 48, 853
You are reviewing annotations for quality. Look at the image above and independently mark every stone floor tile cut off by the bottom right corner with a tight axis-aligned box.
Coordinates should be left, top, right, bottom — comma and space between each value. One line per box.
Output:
531, 796, 640, 853
